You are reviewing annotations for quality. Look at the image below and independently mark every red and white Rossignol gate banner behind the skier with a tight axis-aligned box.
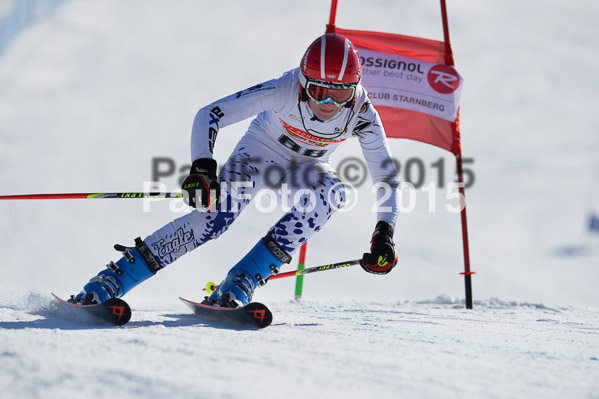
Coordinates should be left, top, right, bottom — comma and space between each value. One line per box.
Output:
334, 27, 463, 155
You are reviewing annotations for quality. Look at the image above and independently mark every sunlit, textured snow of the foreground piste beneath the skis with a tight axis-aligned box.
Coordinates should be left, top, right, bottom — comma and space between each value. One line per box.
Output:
0, 296, 599, 398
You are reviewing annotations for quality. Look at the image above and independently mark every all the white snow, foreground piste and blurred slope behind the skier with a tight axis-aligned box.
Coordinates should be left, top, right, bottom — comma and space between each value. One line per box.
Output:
0, 0, 599, 399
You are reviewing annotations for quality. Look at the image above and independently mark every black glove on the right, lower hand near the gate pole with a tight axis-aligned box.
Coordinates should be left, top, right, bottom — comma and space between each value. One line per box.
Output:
360, 221, 397, 274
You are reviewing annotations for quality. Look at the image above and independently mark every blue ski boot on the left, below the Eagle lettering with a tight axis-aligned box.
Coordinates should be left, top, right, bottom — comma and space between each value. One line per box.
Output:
69, 237, 162, 305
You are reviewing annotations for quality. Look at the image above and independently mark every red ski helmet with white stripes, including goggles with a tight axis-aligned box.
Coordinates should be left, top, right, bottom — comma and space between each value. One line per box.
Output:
300, 33, 362, 106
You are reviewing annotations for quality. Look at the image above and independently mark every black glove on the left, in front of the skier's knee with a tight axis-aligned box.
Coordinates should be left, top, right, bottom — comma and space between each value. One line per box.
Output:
181, 158, 220, 211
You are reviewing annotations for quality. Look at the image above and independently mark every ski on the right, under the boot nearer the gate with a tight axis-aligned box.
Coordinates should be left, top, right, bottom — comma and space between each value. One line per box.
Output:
179, 297, 272, 329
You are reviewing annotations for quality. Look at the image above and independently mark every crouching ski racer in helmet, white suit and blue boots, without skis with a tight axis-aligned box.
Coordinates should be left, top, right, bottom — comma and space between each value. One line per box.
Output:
70, 33, 398, 307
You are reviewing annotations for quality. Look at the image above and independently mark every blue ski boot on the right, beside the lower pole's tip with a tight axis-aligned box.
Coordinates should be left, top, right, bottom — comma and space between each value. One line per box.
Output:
202, 236, 291, 308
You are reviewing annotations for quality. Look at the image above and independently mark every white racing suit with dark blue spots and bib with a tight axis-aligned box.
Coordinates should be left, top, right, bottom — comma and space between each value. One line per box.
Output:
145, 68, 398, 267
